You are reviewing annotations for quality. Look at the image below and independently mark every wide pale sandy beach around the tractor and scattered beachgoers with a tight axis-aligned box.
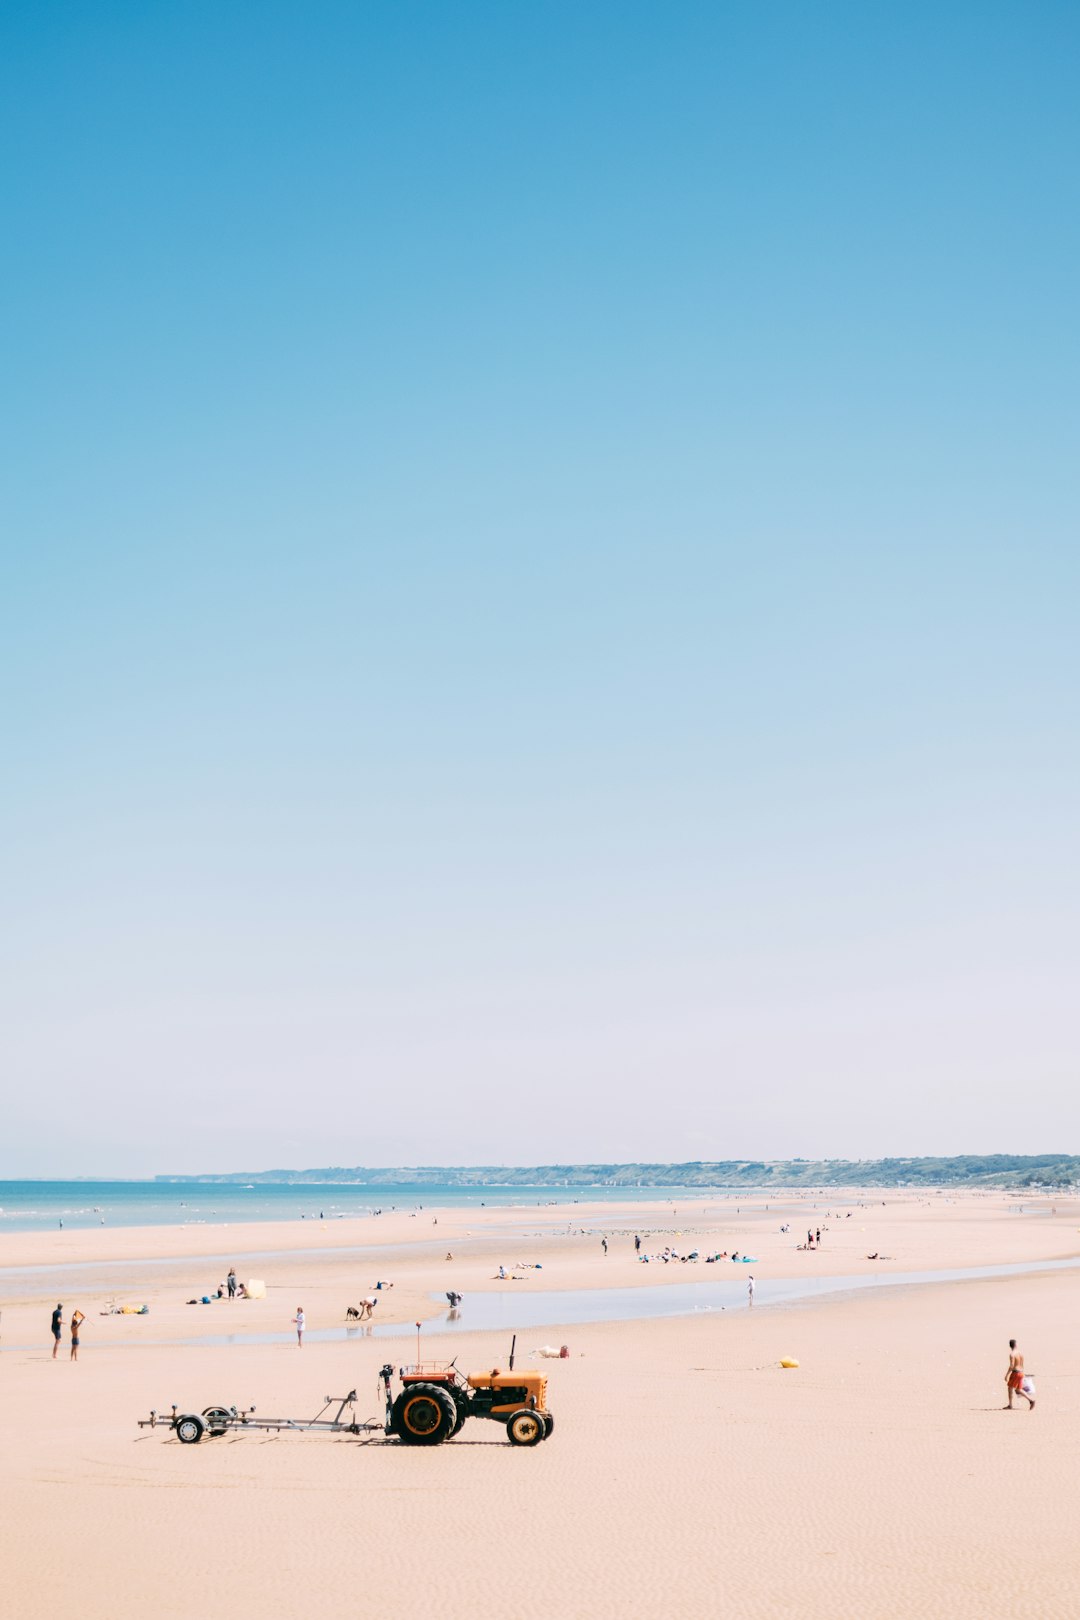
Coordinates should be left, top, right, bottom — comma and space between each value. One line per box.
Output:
0, 1189, 1080, 1620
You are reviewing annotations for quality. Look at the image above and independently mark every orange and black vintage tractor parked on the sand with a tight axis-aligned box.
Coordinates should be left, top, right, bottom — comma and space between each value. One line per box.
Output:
381, 1351, 555, 1445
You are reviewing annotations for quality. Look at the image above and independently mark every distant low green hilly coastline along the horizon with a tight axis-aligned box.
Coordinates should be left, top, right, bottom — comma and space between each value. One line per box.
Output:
154, 1153, 1080, 1189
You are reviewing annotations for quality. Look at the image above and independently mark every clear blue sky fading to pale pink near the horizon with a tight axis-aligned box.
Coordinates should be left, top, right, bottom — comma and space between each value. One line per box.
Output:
0, 0, 1080, 1176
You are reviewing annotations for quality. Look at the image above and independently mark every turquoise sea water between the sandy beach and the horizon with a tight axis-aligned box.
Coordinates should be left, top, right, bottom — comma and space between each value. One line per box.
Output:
0, 1181, 711, 1238
